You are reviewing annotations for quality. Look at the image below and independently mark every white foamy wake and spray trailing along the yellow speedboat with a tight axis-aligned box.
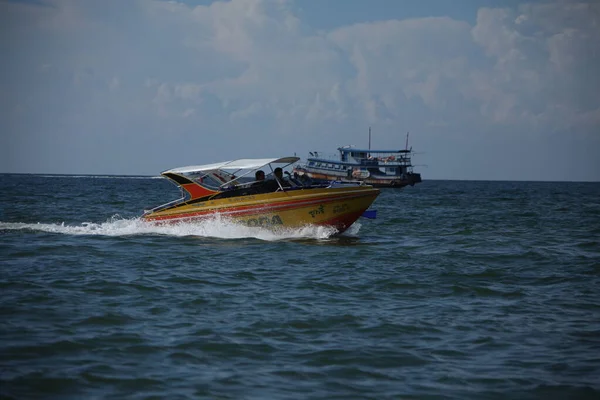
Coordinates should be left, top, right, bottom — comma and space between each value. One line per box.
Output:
0, 215, 346, 241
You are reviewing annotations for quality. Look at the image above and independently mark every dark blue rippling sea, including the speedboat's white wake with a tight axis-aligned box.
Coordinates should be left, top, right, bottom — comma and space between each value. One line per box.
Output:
0, 175, 600, 399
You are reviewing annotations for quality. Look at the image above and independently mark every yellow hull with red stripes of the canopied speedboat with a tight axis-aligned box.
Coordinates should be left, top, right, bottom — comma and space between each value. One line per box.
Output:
144, 186, 380, 232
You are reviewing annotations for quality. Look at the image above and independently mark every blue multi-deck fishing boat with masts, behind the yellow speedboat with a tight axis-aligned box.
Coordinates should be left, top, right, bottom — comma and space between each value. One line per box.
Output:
294, 129, 421, 188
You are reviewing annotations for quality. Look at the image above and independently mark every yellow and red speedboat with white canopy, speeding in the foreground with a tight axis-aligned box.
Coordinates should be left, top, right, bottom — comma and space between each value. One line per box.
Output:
142, 157, 380, 233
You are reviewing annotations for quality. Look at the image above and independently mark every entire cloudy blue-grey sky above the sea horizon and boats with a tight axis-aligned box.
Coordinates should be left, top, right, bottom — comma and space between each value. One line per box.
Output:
0, 0, 600, 181
